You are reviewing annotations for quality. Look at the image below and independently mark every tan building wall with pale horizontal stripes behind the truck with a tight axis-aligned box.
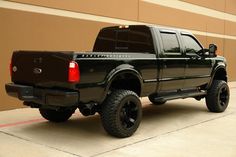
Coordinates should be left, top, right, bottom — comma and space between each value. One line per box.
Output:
0, 0, 236, 110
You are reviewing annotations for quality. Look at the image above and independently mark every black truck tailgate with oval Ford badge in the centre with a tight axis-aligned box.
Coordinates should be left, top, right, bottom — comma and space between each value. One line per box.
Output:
11, 51, 74, 87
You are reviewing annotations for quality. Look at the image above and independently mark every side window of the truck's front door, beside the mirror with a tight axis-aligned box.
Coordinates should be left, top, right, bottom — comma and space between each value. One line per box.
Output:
182, 35, 202, 53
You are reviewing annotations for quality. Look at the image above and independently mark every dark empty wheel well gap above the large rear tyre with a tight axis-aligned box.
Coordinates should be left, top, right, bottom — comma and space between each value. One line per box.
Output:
110, 73, 141, 96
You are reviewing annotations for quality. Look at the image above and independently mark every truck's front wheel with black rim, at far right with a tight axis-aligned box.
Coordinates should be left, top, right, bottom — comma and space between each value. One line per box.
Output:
206, 80, 230, 112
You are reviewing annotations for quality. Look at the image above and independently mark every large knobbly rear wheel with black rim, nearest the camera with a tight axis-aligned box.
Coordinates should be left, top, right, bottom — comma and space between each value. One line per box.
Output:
101, 90, 142, 138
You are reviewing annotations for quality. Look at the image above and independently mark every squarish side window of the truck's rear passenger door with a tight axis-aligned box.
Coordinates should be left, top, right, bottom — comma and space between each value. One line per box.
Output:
161, 32, 180, 52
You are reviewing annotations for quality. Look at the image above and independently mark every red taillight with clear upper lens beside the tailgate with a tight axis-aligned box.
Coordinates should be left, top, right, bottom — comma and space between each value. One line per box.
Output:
68, 61, 80, 83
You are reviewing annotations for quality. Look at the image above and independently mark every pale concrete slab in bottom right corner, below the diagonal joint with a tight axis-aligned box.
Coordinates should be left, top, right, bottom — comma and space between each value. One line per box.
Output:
98, 114, 236, 157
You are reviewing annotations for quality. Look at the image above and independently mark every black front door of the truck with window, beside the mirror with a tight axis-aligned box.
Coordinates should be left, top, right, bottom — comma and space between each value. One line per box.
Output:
181, 33, 212, 88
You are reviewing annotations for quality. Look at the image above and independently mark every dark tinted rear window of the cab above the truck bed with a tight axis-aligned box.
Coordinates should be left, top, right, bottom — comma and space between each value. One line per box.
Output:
93, 26, 154, 53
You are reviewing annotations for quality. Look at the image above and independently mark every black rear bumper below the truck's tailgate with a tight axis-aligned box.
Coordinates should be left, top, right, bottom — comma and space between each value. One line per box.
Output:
5, 83, 79, 107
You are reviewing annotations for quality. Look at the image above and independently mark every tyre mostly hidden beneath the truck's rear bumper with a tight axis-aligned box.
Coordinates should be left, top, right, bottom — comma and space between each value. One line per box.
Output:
39, 108, 75, 122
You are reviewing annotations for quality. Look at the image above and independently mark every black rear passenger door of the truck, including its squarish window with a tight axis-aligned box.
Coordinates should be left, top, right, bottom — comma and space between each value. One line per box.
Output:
158, 30, 185, 91
